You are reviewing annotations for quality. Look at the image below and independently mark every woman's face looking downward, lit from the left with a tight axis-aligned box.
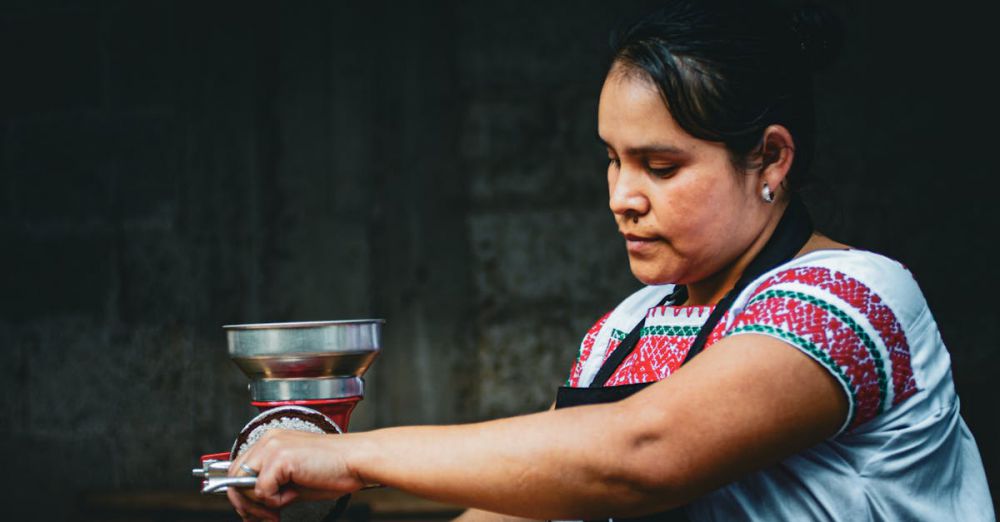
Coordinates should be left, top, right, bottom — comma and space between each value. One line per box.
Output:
598, 67, 769, 284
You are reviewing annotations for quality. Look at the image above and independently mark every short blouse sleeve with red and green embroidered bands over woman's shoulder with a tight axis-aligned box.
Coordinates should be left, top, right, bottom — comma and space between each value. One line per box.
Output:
727, 249, 946, 429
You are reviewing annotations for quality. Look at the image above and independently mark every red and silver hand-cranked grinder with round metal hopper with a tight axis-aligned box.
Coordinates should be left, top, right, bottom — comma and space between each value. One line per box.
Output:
193, 319, 385, 494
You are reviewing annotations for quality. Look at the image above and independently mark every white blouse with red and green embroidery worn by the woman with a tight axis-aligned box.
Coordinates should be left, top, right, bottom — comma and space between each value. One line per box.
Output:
568, 250, 995, 520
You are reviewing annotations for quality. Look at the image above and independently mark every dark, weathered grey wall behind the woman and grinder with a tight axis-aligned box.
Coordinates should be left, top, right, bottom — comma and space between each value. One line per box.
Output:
0, 0, 1000, 518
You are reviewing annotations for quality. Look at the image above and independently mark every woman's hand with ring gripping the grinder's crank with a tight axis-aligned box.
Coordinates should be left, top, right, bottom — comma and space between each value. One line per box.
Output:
227, 429, 364, 520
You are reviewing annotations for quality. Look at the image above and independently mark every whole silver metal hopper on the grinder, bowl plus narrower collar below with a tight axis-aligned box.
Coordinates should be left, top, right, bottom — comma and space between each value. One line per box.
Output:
223, 319, 385, 401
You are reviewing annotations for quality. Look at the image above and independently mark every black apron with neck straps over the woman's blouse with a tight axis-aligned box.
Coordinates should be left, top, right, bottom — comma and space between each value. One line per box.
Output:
555, 197, 813, 522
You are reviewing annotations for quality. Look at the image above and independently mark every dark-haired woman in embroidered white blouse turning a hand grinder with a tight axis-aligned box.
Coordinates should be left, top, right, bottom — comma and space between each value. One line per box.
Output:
229, 1, 994, 520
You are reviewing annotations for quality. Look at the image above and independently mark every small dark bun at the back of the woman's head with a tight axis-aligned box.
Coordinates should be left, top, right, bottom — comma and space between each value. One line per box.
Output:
792, 4, 844, 72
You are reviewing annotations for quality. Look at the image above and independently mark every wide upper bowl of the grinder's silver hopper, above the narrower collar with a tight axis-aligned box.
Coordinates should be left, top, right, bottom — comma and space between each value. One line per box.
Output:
223, 319, 385, 381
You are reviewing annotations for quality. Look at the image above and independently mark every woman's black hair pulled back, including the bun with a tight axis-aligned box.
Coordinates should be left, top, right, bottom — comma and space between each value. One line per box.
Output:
611, 0, 843, 189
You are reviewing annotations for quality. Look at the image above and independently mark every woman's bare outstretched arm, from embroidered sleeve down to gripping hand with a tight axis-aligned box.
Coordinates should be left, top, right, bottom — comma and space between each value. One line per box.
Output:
230, 335, 847, 518
